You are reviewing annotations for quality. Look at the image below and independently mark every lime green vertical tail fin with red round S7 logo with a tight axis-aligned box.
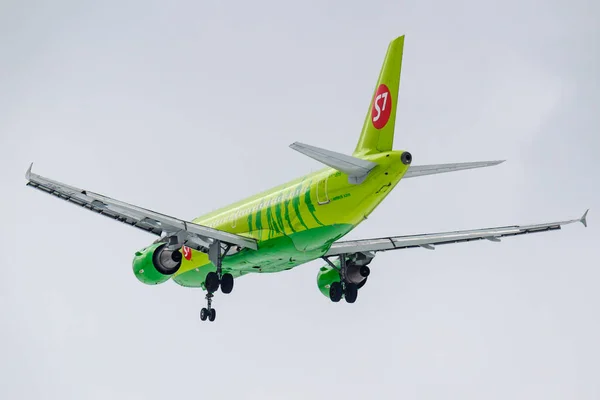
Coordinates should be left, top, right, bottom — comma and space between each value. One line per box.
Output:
353, 36, 404, 156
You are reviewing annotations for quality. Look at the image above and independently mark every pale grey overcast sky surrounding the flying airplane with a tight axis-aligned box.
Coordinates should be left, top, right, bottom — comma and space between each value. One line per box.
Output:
0, 0, 600, 399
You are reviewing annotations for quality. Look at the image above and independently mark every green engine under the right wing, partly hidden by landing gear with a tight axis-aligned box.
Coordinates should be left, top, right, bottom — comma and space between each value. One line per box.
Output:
317, 253, 373, 298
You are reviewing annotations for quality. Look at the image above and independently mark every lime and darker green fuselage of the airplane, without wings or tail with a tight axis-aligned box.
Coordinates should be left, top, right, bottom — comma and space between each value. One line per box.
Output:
166, 151, 408, 287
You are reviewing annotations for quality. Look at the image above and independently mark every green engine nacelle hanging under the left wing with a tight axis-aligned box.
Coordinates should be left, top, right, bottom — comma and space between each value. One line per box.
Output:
133, 243, 182, 285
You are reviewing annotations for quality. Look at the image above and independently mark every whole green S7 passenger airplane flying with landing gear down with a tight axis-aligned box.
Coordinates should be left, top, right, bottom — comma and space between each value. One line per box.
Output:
26, 36, 589, 321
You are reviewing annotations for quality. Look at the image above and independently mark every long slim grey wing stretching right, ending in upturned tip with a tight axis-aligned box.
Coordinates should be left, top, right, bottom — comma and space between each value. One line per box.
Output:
325, 210, 589, 257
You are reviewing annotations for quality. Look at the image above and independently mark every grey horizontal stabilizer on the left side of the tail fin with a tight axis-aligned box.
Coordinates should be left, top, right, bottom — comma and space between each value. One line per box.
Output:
290, 142, 377, 184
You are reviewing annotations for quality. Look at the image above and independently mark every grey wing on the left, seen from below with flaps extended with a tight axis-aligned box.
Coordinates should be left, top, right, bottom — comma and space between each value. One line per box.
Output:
25, 164, 258, 251
